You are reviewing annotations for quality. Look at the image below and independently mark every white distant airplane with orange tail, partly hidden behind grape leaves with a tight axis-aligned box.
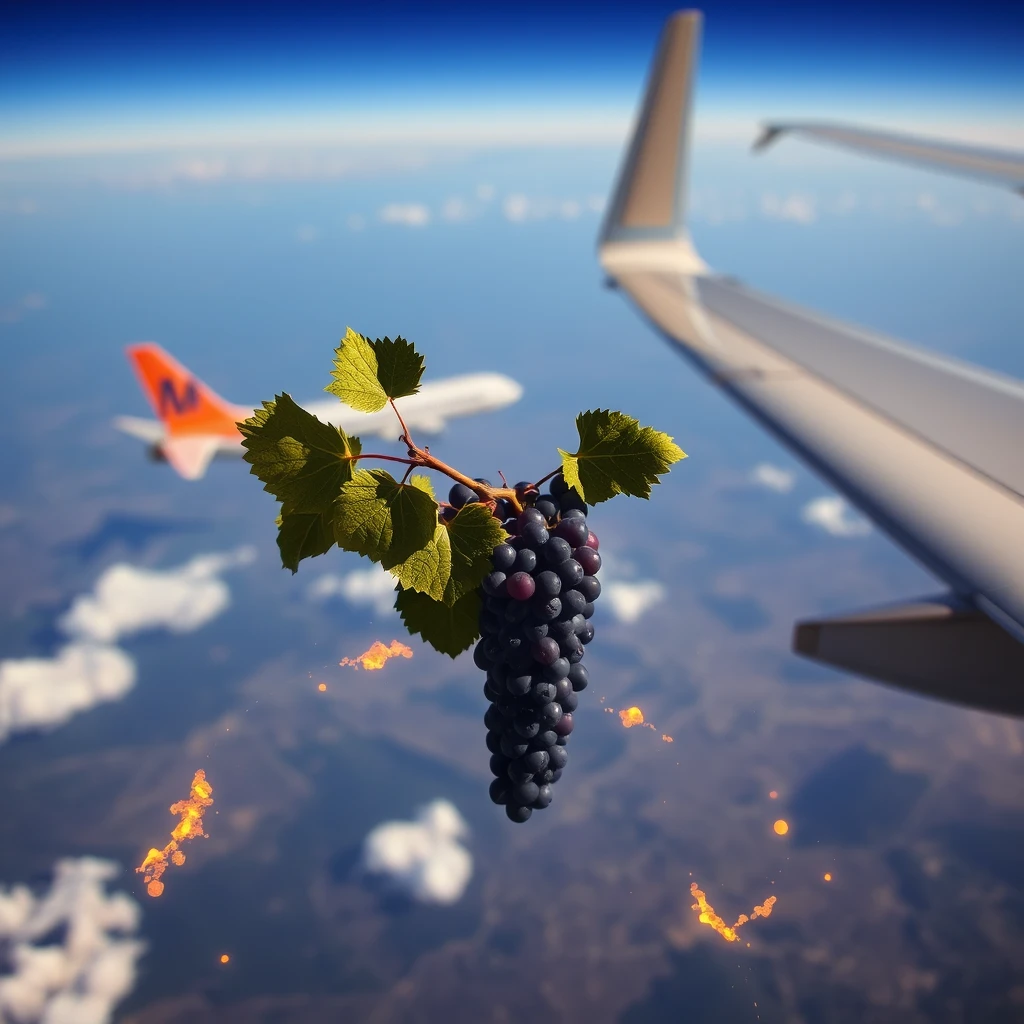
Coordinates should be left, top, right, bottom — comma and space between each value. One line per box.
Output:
114, 342, 522, 480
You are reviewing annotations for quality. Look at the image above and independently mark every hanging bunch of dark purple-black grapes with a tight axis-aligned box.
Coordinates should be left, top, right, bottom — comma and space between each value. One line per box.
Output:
449, 473, 601, 821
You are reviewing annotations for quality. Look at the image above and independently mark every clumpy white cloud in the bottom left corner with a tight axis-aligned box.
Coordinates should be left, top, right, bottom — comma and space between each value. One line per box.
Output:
0, 857, 145, 1024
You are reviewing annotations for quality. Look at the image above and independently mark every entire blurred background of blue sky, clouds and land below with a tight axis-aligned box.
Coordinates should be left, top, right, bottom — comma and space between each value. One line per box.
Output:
0, 4, 1024, 1024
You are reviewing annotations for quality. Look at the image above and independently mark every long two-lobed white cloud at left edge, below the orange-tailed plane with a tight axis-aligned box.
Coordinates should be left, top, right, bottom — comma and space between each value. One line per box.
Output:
0, 548, 255, 741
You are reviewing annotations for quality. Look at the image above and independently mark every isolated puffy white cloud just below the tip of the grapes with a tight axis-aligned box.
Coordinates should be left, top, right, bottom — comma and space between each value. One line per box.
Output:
362, 800, 473, 903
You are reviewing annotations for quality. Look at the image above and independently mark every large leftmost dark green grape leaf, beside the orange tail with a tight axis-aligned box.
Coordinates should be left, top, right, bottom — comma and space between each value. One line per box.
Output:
239, 394, 362, 514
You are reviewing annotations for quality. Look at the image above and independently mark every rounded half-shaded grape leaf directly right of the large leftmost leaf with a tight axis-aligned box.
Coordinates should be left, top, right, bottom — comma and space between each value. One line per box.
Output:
334, 469, 437, 569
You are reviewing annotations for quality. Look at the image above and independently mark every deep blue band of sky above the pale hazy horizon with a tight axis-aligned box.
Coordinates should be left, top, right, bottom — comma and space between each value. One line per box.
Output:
6, 0, 1024, 121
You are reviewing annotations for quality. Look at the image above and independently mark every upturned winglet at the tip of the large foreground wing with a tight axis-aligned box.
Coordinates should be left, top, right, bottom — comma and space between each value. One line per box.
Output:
599, 10, 707, 273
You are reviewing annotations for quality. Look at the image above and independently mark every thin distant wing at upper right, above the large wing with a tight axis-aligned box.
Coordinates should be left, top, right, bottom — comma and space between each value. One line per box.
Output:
754, 121, 1024, 195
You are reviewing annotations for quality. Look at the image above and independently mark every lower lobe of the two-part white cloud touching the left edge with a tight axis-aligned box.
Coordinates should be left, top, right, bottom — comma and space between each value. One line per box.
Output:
0, 643, 135, 740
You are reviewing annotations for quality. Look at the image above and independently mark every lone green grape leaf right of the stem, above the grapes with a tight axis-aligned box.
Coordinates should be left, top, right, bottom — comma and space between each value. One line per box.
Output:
558, 409, 686, 505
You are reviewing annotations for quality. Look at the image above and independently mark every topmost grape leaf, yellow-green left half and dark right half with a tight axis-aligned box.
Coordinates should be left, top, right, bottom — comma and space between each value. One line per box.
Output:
324, 328, 423, 413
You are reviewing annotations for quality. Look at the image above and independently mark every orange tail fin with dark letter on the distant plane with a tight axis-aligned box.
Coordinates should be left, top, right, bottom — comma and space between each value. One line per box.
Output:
126, 341, 244, 437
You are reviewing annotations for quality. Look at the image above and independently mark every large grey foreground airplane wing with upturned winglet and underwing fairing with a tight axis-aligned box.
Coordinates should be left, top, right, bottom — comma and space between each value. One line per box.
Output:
599, 11, 1024, 715
